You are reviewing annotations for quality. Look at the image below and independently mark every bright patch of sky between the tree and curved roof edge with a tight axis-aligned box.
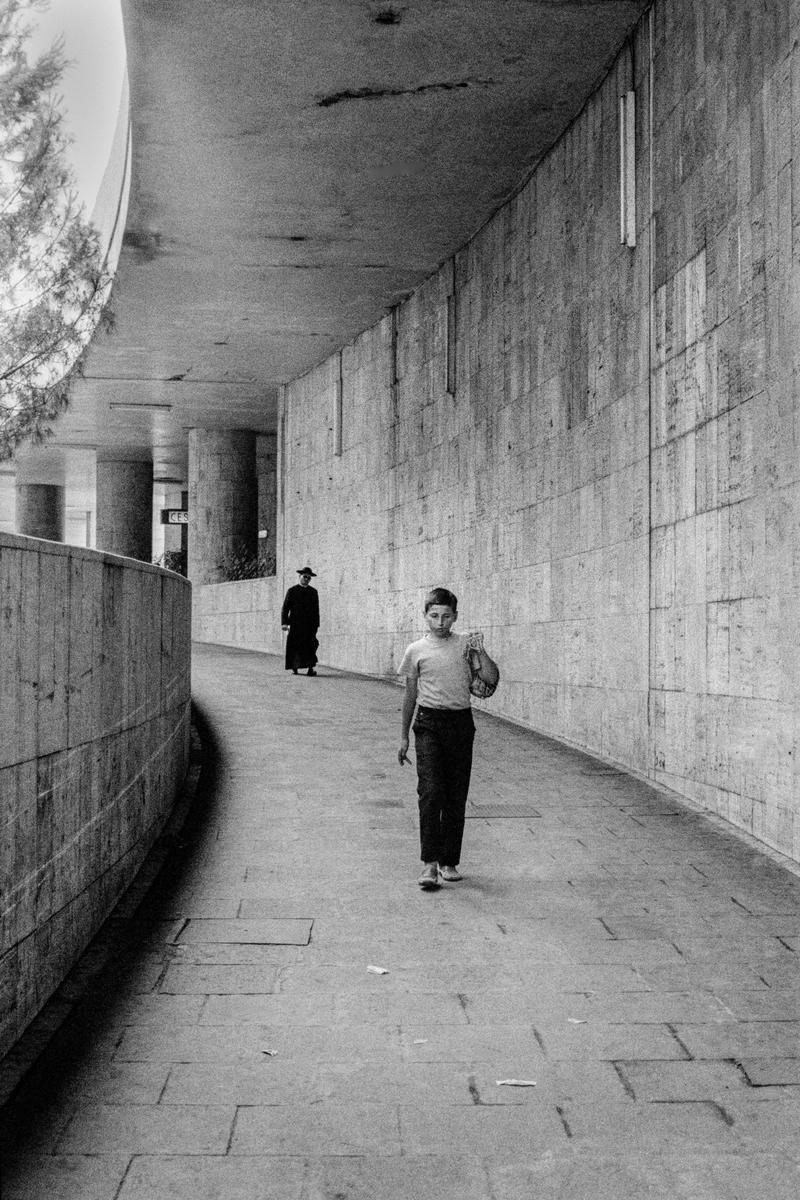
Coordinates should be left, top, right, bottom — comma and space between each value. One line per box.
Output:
29, 0, 125, 214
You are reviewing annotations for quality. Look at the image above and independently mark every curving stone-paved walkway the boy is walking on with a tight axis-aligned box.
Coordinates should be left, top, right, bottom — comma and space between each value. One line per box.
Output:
2, 647, 800, 1200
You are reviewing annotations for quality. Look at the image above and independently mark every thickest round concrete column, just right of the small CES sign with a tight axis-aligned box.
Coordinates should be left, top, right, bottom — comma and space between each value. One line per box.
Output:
188, 430, 258, 583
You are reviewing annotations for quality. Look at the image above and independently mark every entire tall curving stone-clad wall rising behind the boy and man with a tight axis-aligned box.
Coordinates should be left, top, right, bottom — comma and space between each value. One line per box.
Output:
194, 0, 800, 858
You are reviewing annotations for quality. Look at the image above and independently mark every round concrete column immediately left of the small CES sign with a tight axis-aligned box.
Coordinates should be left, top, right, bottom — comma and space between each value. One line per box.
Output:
96, 461, 152, 563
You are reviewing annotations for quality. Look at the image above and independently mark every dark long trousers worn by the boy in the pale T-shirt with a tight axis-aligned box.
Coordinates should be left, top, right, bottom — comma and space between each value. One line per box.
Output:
414, 708, 475, 866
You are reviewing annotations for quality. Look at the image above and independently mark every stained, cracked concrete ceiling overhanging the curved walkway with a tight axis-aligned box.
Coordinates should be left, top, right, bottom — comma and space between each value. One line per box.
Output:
14, 0, 648, 492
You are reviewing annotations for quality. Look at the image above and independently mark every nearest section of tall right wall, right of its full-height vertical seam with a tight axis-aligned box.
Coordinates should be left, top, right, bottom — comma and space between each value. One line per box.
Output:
650, 0, 800, 859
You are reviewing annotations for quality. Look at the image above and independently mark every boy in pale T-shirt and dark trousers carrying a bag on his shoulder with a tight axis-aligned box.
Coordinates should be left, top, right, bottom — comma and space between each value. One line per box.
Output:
397, 588, 500, 890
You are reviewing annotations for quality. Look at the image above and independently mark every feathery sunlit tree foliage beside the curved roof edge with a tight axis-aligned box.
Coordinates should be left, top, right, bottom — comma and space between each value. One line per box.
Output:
0, 0, 112, 461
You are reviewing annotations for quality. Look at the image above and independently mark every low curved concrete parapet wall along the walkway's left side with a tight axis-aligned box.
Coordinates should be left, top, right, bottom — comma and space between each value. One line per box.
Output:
0, 534, 191, 1056
